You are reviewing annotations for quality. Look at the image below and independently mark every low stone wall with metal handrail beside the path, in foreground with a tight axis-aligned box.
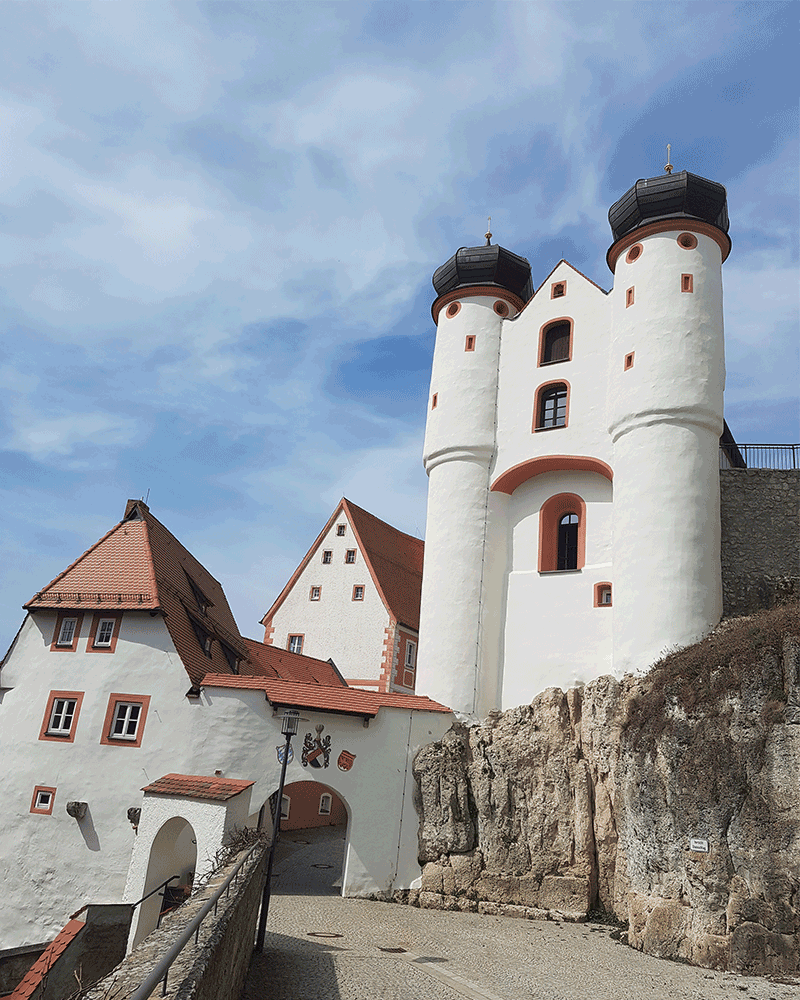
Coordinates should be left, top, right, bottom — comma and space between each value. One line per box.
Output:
81, 845, 269, 1000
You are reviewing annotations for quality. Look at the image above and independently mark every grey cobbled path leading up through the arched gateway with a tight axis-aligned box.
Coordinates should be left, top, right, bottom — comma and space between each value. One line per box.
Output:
242, 828, 800, 1000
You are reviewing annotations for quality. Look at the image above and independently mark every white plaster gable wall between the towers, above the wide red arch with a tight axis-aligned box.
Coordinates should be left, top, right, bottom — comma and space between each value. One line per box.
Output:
492, 263, 611, 481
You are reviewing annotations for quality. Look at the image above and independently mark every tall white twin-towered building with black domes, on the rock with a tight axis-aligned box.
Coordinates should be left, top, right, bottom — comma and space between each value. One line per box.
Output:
417, 171, 730, 716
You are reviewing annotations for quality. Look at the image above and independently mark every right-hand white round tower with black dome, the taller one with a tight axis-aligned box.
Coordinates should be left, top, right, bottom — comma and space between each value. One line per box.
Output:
607, 171, 730, 674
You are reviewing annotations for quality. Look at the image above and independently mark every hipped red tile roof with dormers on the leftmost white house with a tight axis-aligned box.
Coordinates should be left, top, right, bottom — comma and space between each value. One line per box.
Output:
25, 500, 252, 684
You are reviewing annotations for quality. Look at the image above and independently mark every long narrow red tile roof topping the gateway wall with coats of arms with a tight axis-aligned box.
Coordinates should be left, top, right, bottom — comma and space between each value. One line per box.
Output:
203, 674, 450, 718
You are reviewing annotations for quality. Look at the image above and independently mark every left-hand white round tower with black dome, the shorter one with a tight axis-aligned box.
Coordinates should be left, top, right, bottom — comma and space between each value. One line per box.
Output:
416, 236, 533, 715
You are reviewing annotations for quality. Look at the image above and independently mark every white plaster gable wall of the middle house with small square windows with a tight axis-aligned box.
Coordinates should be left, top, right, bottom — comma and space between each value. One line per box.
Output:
272, 514, 389, 681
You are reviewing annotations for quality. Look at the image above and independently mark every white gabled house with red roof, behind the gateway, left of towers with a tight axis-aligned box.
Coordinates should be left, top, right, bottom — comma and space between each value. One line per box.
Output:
261, 499, 424, 692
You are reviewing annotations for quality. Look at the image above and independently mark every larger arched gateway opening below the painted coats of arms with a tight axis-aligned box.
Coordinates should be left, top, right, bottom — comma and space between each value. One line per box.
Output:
265, 781, 350, 896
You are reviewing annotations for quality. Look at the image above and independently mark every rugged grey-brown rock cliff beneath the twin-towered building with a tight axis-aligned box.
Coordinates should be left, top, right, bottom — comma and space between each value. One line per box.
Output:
414, 604, 800, 973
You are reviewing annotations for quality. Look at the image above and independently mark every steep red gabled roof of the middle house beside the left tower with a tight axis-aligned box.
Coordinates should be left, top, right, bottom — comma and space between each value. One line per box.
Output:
261, 498, 425, 631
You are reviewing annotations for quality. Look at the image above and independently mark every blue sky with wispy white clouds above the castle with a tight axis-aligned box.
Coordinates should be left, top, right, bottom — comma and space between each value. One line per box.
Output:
0, 0, 800, 650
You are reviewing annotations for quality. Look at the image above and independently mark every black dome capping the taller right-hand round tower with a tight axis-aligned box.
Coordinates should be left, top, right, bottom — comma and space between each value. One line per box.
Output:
608, 170, 729, 242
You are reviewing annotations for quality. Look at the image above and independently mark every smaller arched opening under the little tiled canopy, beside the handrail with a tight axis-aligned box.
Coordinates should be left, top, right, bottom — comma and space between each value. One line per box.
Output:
132, 816, 197, 948
